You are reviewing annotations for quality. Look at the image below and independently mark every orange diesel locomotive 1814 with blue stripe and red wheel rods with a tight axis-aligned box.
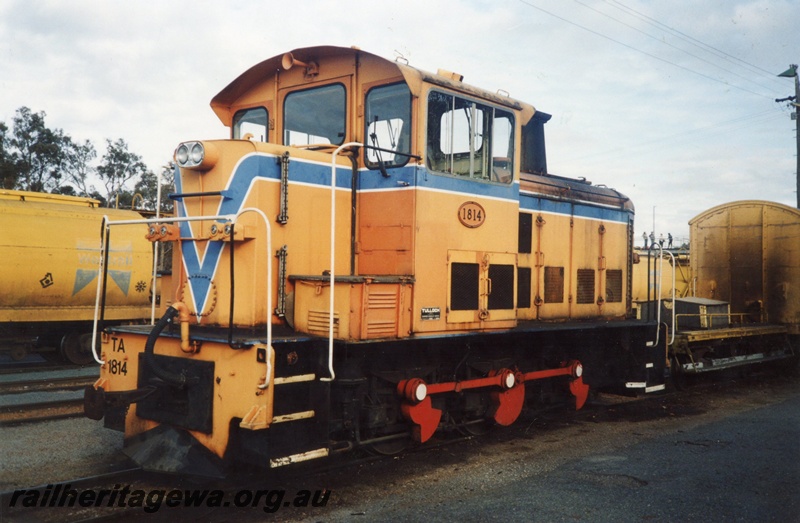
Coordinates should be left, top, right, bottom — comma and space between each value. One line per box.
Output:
86, 47, 666, 473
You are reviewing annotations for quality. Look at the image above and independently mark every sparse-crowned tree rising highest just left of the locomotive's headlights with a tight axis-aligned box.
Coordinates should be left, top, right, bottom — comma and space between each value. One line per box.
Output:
97, 138, 148, 207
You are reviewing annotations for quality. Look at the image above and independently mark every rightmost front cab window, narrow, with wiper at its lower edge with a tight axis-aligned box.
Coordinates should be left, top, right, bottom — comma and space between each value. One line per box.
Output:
364, 83, 411, 167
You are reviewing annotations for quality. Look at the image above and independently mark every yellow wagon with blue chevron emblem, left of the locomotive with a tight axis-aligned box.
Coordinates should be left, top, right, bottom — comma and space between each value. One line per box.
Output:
0, 190, 153, 364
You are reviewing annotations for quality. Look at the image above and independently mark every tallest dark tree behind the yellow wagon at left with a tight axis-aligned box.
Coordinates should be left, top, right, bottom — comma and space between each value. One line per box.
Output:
9, 107, 72, 192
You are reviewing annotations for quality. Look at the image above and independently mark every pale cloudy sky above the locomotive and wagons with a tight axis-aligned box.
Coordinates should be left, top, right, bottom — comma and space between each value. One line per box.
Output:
0, 0, 800, 242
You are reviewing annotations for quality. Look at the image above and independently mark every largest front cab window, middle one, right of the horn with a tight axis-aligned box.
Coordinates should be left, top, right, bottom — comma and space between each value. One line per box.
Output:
283, 84, 346, 145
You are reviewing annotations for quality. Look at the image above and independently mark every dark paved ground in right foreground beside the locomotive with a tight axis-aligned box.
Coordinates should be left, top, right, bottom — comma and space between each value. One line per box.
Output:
276, 378, 800, 522
